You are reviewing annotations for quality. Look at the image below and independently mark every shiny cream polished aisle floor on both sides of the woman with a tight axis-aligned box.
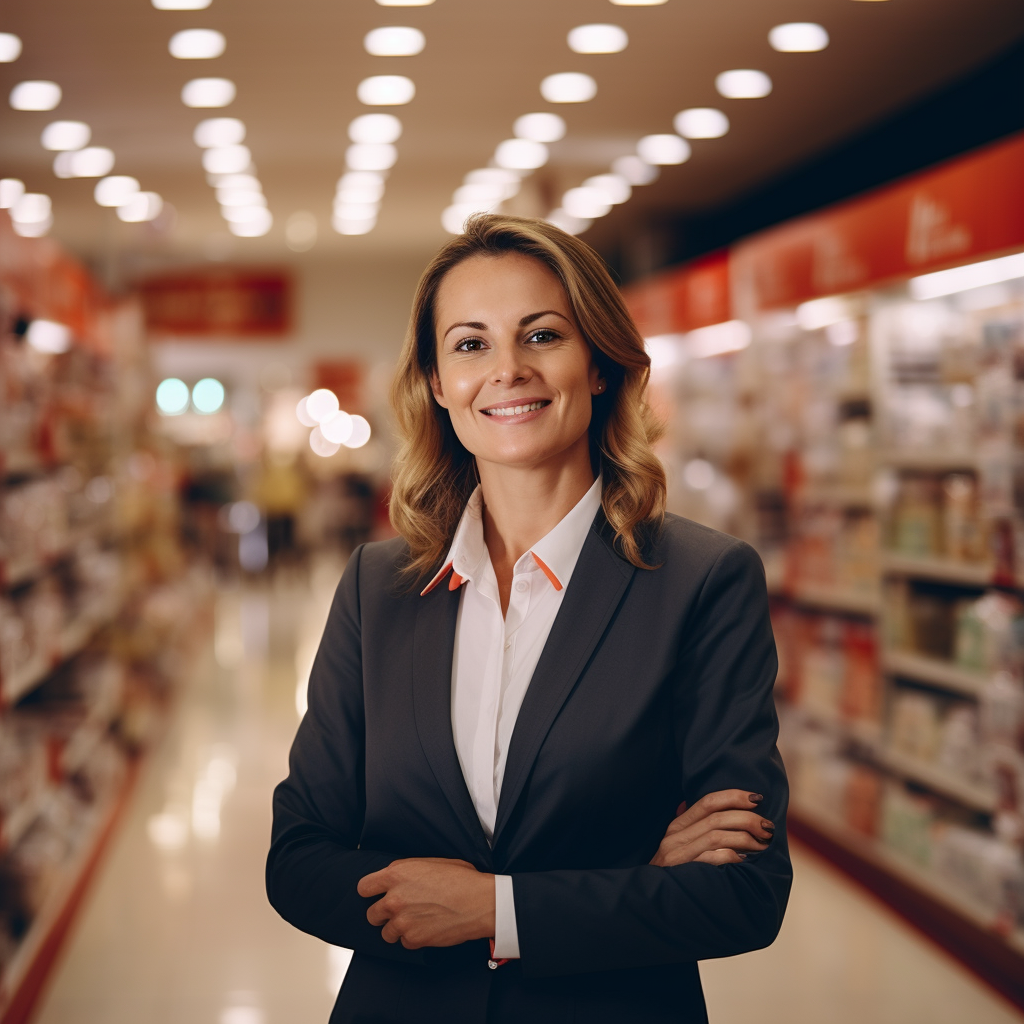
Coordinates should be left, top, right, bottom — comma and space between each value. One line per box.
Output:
34, 560, 1024, 1024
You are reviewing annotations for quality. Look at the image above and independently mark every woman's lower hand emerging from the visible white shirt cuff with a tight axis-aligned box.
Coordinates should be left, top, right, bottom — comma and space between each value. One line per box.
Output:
356, 857, 495, 949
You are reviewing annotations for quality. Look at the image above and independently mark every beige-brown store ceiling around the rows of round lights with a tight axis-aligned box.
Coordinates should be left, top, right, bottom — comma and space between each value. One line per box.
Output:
0, 0, 1024, 267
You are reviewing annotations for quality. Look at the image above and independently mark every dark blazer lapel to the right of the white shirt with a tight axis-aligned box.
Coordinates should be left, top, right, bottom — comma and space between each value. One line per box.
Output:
493, 524, 636, 848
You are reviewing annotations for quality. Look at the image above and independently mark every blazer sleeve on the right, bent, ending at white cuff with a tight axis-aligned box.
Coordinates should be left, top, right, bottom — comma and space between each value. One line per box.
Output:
513, 542, 792, 977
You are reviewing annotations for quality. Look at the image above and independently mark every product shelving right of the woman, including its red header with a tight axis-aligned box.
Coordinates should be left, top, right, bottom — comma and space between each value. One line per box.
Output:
628, 136, 1024, 1008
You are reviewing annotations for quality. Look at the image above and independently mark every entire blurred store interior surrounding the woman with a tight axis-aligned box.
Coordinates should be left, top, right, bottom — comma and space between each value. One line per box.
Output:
0, 0, 1024, 1024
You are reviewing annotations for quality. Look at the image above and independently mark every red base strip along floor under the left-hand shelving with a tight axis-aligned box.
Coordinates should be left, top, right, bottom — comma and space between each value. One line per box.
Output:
0, 762, 137, 1024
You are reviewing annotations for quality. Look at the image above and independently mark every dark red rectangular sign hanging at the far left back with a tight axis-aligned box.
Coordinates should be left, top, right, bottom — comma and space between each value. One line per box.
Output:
141, 270, 292, 340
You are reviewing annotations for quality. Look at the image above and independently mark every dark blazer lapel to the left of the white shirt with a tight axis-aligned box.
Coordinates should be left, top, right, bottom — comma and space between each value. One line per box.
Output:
413, 587, 490, 863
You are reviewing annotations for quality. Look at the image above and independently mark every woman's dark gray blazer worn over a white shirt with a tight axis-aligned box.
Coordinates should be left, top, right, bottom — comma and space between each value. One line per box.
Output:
266, 513, 792, 1024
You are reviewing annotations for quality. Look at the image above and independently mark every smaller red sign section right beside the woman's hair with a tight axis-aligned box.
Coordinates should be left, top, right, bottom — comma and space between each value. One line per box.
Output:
624, 252, 732, 338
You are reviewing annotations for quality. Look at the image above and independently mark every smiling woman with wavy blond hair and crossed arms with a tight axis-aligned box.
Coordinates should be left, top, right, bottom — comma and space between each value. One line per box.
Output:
267, 215, 791, 1024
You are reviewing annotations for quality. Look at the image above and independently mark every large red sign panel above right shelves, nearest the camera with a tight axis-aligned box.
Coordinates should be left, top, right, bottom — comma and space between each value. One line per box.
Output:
731, 136, 1024, 315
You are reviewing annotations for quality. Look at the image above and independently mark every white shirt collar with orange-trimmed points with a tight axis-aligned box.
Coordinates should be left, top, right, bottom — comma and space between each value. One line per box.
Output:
420, 476, 601, 597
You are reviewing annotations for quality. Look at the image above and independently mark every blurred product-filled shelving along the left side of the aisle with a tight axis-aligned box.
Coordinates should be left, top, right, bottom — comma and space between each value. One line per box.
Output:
0, 212, 210, 1024
